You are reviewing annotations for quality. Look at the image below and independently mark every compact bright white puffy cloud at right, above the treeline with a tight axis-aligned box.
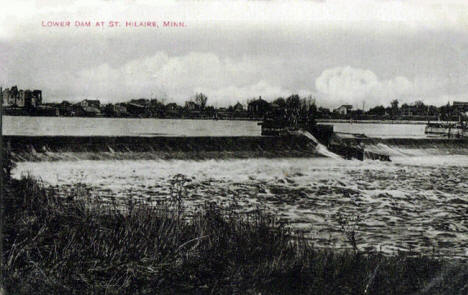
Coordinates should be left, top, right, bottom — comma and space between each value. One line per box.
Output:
315, 66, 414, 105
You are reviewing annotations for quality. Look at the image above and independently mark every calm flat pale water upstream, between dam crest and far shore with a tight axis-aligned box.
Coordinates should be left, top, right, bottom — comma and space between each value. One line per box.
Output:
3, 116, 424, 137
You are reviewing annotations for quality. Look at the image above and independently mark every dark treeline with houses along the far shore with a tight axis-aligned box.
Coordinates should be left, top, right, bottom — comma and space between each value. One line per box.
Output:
5, 93, 468, 120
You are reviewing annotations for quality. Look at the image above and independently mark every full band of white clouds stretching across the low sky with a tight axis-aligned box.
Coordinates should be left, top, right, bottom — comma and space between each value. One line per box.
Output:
11, 51, 468, 107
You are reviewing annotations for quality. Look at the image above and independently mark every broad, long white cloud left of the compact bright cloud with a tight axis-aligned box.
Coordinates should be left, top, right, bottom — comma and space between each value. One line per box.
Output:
48, 51, 300, 105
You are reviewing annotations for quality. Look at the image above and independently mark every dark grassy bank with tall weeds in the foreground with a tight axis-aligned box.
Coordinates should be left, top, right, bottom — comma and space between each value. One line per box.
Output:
3, 178, 468, 294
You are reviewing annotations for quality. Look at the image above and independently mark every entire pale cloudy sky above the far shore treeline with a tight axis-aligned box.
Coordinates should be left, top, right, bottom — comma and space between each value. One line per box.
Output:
0, 0, 468, 109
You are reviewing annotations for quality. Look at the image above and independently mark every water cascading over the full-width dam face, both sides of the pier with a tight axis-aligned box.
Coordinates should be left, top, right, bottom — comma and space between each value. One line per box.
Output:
4, 134, 468, 161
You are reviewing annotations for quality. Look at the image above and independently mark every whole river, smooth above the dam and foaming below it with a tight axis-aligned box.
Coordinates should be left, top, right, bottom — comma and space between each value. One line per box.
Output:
4, 116, 468, 259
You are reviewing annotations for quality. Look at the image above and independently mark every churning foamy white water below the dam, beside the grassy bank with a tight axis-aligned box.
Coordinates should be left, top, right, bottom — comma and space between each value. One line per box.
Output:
14, 151, 468, 258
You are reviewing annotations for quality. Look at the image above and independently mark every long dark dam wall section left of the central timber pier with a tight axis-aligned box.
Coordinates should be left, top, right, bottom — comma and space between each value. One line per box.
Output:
4, 136, 319, 161
